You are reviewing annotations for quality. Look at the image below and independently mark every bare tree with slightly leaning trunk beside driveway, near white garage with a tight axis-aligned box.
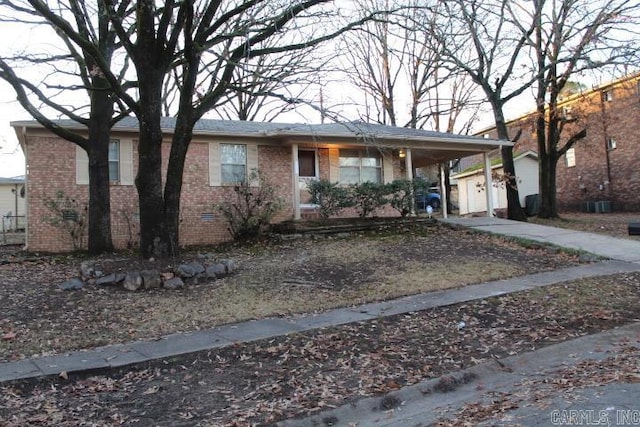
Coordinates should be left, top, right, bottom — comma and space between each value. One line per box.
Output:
431, 0, 535, 221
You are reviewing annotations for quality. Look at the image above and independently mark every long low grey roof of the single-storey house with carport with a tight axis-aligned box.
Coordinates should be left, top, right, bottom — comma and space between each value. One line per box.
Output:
11, 117, 513, 166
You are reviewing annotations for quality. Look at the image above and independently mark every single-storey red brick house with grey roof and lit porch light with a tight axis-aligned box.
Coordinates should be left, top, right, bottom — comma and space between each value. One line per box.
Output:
12, 118, 504, 251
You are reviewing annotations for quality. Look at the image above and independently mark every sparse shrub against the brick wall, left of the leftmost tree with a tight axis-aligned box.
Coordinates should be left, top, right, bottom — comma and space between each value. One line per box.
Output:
43, 190, 89, 251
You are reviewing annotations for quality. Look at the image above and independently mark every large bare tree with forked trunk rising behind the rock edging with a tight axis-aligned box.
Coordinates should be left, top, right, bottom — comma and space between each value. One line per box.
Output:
29, 0, 380, 258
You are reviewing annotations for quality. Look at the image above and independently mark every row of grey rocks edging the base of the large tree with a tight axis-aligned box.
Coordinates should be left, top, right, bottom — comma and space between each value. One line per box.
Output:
58, 257, 237, 292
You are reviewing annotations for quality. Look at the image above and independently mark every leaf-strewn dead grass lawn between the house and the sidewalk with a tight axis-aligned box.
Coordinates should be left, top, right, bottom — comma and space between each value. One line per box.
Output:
0, 225, 577, 360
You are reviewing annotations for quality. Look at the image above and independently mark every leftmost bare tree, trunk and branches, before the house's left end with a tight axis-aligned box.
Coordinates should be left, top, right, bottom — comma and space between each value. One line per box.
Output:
0, 0, 132, 254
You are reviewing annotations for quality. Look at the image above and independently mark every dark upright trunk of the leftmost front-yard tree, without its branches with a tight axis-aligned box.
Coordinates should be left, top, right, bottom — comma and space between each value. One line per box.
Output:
87, 77, 113, 255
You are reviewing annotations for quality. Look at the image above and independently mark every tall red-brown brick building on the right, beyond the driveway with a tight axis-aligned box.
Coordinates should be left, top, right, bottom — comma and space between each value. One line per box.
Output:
464, 74, 640, 211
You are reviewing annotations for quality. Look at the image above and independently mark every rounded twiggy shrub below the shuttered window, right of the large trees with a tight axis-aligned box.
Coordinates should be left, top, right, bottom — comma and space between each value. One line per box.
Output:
215, 170, 284, 240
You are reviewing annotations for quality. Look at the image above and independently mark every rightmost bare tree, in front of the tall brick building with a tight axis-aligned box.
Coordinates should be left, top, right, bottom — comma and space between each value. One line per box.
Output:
515, 0, 640, 218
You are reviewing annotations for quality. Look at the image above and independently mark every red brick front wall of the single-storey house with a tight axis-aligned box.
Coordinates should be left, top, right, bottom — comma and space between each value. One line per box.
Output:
27, 135, 401, 252
